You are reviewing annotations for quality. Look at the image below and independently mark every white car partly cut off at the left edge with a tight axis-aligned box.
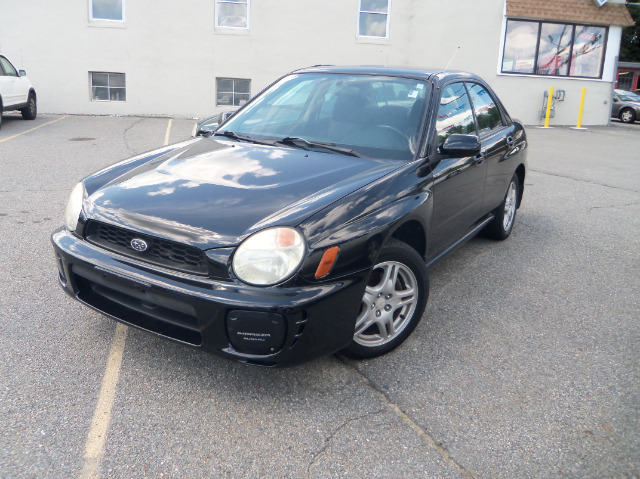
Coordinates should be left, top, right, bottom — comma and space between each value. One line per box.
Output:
0, 55, 38, 127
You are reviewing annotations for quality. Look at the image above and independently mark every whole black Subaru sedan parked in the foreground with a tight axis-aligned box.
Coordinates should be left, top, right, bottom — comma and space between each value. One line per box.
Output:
52, 67, 527, 366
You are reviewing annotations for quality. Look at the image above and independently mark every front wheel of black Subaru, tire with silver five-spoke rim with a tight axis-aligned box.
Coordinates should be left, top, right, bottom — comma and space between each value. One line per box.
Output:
341, 239, 429, 359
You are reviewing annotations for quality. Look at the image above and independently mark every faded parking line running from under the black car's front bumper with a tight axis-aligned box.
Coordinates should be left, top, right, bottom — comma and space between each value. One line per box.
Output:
80, 323, 129, 479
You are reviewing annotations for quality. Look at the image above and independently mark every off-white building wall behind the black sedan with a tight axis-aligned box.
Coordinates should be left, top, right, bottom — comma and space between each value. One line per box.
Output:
0, 0, 620, 125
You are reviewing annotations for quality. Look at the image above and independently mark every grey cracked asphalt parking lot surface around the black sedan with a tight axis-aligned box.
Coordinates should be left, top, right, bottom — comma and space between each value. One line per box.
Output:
0, 110, 640, 478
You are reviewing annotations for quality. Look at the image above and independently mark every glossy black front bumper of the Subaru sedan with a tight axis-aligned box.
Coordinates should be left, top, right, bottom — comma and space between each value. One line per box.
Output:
51, 229, 368, 366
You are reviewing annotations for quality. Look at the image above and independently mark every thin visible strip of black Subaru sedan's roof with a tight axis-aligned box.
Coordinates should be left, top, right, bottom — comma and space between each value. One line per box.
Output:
293, 65, 481, 82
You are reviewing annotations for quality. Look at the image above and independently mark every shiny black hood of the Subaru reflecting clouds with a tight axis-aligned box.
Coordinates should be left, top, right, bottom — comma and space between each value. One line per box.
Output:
84, 139, 402, 249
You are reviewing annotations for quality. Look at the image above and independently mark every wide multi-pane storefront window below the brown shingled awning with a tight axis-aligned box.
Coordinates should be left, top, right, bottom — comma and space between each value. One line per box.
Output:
502, 20, 608, 78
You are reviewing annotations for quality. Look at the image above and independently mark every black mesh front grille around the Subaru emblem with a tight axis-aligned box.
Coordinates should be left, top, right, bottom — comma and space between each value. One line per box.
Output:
86, 221, 209, 275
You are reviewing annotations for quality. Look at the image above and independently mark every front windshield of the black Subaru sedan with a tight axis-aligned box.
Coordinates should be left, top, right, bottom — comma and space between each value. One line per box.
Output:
221, 73, 429, 160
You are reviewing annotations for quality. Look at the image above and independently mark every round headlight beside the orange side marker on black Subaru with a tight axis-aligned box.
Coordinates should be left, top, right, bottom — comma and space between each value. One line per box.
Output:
232, 227, 305, 286
